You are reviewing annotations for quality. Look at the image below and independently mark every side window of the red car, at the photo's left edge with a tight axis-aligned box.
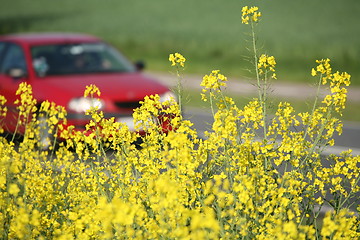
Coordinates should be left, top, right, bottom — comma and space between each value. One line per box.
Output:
0, 44, 26, 73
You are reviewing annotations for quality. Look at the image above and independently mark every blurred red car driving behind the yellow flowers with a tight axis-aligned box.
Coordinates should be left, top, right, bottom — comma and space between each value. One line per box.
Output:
0, 33, 175, 143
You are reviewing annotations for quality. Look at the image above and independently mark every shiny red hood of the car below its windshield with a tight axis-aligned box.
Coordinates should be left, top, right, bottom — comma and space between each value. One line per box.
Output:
32, 73, 168, 106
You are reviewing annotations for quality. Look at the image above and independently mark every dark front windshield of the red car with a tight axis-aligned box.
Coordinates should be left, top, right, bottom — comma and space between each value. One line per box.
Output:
31, 43, 135, 76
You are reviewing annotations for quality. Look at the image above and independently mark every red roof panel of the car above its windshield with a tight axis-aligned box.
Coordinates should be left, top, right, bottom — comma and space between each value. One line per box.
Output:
0, 33, 100, 45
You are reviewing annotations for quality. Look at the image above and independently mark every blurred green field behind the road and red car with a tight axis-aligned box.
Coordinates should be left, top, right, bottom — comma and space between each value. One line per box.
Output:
0, 0, 360, 120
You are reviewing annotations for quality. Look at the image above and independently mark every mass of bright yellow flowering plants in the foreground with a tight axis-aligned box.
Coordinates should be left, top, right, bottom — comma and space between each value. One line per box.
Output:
0, 4, 360, 239
